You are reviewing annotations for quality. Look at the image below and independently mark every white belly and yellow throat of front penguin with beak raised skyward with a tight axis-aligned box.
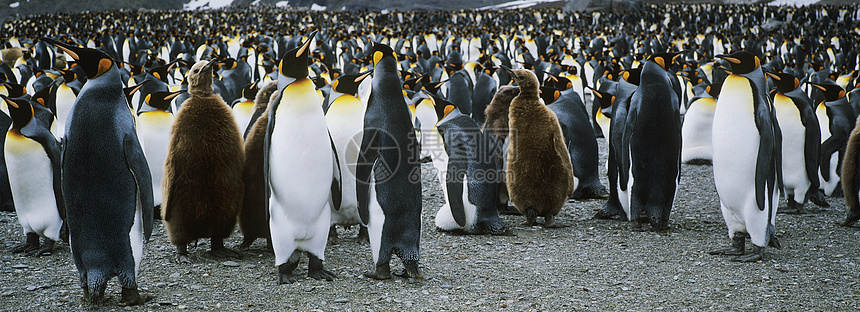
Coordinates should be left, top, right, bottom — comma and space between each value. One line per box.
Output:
268, 79, 334, 264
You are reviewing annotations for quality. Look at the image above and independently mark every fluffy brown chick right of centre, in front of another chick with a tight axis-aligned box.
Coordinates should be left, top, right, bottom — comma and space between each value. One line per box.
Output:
506, 69, 574, 227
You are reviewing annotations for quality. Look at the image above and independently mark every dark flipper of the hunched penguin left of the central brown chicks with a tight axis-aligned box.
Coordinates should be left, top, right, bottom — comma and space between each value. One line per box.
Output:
444, 131, 469, 227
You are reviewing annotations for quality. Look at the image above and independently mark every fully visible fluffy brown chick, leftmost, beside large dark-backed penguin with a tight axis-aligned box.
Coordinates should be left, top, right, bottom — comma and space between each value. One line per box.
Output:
161, 61, 245, 263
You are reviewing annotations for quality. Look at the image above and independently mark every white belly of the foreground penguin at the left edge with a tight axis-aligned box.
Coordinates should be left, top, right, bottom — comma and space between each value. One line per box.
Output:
5, 133, 63, 241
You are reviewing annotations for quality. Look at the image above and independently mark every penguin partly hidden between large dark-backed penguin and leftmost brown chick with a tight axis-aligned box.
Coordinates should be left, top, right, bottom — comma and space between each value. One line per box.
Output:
137, 90, 185, 212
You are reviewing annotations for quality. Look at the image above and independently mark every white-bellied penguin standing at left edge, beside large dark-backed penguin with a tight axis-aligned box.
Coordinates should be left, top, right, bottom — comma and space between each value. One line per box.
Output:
0, 95, 68, 256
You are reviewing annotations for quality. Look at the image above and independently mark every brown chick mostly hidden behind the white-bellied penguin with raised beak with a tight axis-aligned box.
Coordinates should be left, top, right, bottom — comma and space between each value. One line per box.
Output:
239, 82, 278, 249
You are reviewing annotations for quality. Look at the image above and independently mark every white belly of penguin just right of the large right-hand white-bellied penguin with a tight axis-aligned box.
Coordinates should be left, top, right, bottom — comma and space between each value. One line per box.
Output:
773, 94, 811, 204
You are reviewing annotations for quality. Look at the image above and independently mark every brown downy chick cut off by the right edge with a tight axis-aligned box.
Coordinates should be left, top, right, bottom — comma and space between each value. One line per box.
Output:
841, 117, 860, 226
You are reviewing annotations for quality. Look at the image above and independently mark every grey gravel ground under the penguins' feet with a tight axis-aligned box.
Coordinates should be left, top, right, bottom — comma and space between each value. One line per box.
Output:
0, 129, 860, 311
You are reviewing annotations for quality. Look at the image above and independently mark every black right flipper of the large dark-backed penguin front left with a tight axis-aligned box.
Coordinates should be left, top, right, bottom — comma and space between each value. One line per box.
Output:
122, 133, 155, 241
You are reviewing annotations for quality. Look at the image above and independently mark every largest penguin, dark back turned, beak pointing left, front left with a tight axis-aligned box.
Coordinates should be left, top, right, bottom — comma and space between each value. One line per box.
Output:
42, 38, 153, 305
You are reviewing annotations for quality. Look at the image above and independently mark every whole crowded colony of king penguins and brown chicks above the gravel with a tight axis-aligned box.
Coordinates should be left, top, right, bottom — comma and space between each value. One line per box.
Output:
0, 1, 860, 305
